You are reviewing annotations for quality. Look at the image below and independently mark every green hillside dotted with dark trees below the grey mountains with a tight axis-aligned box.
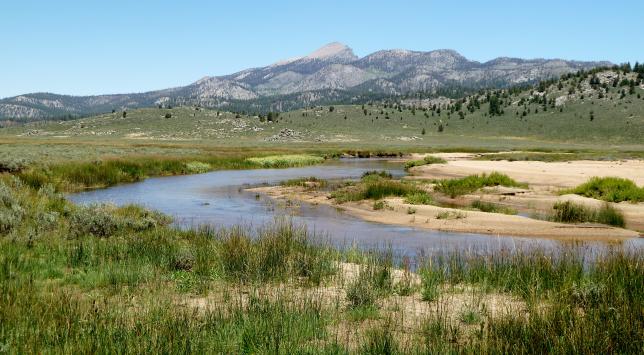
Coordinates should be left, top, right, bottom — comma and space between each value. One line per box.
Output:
0, 70, 644, 146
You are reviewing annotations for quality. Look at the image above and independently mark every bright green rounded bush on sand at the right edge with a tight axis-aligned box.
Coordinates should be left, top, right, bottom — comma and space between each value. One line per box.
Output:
562, 177, 644, 202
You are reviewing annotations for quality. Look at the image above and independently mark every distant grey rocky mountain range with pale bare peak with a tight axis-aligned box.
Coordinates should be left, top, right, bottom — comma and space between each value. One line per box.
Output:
0, 42, 612, 120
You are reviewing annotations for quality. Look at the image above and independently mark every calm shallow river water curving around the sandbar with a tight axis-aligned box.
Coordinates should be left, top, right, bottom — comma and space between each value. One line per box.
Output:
69, 159, 644, 256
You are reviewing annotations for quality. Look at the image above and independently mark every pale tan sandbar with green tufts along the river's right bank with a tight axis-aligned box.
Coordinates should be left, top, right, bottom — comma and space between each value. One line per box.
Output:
250, 153, 644, 241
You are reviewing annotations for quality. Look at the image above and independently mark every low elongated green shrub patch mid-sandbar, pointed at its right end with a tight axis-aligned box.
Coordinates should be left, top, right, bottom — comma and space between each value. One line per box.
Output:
434, 172, 527, 198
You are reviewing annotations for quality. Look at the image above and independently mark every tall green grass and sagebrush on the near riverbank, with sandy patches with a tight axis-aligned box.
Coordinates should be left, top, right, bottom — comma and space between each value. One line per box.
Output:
0, 174, 644, 353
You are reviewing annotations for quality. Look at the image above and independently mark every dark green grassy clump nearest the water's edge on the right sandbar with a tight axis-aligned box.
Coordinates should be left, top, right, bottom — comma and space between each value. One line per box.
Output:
550, 201, 625, 228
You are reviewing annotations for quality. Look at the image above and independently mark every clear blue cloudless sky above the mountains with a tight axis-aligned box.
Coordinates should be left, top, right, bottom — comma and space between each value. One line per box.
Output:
0, 0, 644, 97
